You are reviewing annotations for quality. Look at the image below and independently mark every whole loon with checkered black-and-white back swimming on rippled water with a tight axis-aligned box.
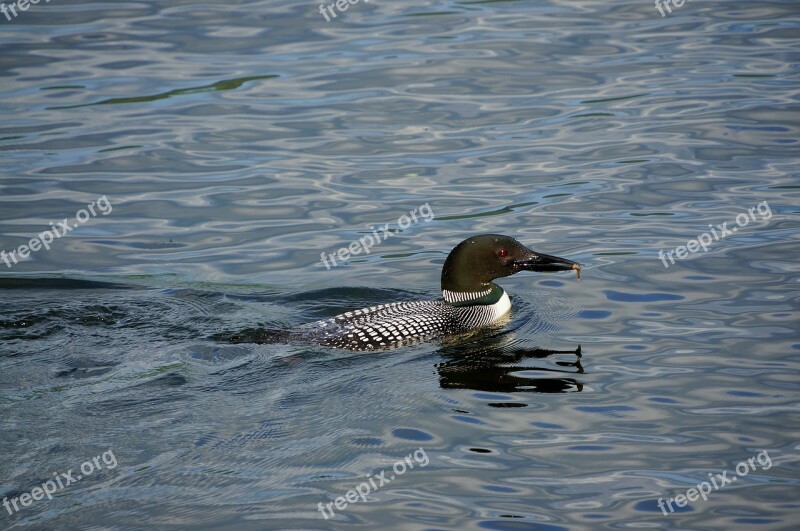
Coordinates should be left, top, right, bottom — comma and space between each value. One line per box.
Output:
293, 234, 581, 351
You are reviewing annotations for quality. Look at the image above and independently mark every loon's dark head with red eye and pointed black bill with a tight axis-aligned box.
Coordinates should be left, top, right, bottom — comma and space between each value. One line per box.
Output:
442, 234, 581, 292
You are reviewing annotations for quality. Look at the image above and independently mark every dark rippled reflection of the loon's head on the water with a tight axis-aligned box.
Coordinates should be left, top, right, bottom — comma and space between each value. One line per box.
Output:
436, 334, 583, 393
